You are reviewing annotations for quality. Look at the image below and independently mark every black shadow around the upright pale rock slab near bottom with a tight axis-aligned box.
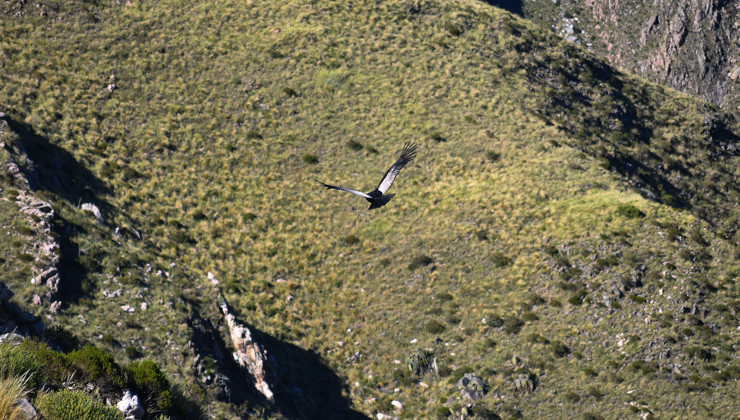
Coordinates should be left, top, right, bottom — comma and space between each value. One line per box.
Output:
187, 302, 367, 420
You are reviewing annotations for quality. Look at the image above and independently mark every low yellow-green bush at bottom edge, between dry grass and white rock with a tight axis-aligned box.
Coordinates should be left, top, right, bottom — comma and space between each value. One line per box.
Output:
36, 390, 123, 420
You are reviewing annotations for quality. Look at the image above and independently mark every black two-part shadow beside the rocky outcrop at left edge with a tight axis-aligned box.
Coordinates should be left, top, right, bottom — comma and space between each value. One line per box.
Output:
5, 117, 110, 302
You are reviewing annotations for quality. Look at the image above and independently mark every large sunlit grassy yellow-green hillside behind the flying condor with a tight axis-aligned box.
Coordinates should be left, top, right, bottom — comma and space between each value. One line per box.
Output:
0, 1, 740, 418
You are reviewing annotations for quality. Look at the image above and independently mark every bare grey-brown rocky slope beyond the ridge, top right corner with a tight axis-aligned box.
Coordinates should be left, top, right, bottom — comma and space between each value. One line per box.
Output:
524, 0, 740, 114
